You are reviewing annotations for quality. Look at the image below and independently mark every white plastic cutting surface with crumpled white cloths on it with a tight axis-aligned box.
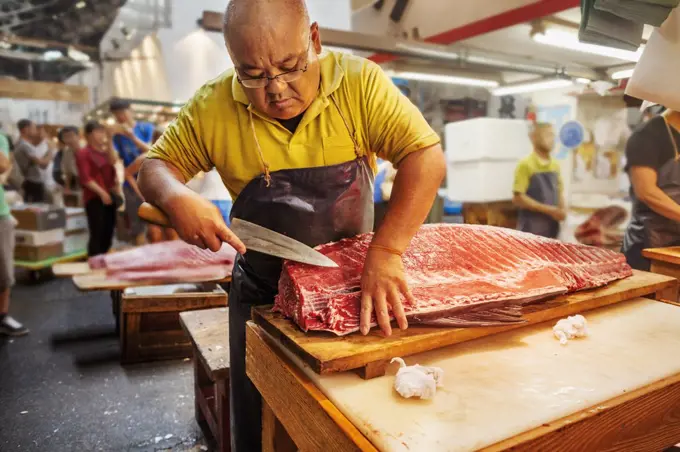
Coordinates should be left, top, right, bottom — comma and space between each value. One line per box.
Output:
274, 298, 680, 452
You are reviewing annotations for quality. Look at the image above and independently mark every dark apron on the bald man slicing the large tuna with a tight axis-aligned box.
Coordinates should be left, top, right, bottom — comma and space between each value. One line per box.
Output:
229, 97, 373, 452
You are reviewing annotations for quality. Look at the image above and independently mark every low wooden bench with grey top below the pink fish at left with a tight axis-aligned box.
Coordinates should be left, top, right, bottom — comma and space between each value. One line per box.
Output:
120, 283, 227, 364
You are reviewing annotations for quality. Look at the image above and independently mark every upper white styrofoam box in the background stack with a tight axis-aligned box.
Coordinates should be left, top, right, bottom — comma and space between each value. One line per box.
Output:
444, 118, 533, 162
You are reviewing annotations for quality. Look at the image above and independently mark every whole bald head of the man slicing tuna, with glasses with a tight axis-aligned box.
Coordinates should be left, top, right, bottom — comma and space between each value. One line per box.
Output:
224, 0, 321, 119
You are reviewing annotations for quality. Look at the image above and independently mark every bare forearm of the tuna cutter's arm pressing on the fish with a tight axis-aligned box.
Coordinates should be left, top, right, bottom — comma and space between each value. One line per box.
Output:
373, 145, 446, 252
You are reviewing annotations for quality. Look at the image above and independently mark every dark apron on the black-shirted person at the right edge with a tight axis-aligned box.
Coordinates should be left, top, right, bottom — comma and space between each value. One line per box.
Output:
621, 118, 680, 271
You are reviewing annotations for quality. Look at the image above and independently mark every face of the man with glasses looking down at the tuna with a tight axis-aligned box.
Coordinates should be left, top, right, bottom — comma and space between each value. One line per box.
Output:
229, 23, 321, 119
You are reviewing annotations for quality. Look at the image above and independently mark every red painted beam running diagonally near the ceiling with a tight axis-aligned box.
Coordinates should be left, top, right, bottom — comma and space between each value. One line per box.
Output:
370, 0, 580, 63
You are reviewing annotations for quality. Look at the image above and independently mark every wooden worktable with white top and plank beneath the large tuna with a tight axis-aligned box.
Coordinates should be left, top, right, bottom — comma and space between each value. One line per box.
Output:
246, 272, 680, 451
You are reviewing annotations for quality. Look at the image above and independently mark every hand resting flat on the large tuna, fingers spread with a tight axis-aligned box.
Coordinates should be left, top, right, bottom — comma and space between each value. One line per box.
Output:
360, 249, 413, 336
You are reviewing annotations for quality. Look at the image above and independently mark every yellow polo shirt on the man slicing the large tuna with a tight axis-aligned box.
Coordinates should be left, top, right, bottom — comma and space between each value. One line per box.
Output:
148, 52, 440, 199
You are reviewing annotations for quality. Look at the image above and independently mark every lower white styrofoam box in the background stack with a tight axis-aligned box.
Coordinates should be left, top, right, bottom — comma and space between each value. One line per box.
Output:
446, 160, 518, 202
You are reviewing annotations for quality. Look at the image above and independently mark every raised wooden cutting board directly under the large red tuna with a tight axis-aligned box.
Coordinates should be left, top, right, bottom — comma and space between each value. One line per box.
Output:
253, 271, 678, 378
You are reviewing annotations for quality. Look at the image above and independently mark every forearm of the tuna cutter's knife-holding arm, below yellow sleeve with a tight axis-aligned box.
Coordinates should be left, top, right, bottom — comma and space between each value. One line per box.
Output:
137, 159, 192, 211
